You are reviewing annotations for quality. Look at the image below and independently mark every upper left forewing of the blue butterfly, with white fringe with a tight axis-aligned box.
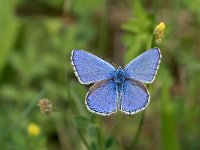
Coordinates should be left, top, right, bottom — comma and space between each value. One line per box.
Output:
71, 50, 115, 84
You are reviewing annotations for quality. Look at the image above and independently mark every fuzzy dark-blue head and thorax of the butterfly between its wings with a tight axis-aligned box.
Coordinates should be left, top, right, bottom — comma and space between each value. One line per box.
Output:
114, 66, 125, 85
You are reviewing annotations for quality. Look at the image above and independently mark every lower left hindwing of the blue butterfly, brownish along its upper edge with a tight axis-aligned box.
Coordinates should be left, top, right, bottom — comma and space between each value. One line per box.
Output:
85, 80, 117, 116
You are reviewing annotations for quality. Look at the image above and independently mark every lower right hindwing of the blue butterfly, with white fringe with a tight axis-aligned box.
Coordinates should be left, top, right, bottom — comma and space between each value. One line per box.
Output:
120, 79, 150, 115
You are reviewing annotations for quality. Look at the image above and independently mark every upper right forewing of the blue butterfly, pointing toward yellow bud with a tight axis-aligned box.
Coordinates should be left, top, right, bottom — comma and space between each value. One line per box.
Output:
125, 48, 161, 83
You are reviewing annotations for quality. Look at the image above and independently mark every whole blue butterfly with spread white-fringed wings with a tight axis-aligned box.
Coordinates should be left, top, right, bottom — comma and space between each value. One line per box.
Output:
71, 48, 162, 116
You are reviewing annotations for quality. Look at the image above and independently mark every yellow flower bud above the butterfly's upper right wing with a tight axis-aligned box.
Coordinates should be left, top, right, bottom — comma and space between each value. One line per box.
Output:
154, 22, 166, 44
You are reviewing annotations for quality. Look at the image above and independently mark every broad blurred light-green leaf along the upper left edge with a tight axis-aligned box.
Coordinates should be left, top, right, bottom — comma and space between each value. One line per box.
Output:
0, 0, 19, 76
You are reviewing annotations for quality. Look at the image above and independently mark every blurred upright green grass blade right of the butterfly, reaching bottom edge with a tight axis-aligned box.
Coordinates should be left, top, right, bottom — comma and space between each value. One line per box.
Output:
161, 67, 180, 150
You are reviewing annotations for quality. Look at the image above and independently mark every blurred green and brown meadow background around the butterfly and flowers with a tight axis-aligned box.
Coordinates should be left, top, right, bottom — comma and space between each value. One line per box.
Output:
0, 0, 200, 150
